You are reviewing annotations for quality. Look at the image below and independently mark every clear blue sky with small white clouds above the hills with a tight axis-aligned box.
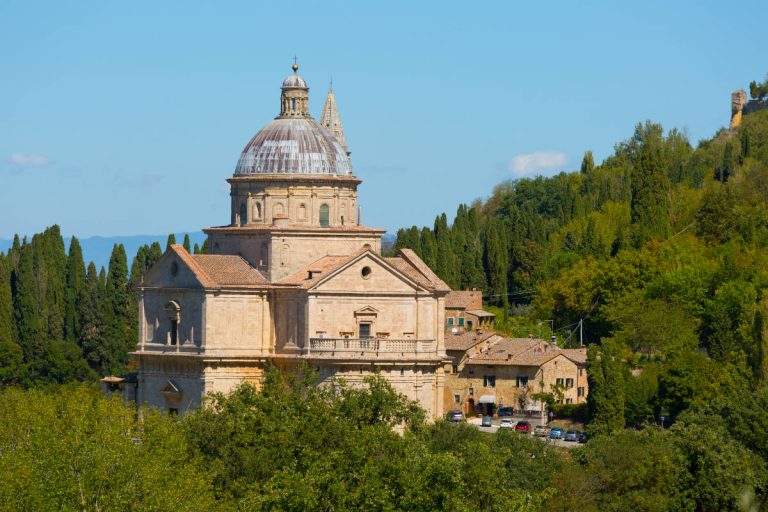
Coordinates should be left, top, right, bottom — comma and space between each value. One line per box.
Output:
0, 0, 768, 238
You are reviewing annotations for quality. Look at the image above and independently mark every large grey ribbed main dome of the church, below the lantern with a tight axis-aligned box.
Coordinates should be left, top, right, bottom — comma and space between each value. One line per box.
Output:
235, 118, 352, 176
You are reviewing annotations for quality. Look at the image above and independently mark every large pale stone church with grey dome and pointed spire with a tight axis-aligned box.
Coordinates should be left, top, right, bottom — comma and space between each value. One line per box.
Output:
127, 64, 450, 418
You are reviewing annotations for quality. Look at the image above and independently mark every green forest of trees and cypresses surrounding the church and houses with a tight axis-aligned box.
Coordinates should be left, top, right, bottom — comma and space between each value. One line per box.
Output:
0, 103, 768, 511
